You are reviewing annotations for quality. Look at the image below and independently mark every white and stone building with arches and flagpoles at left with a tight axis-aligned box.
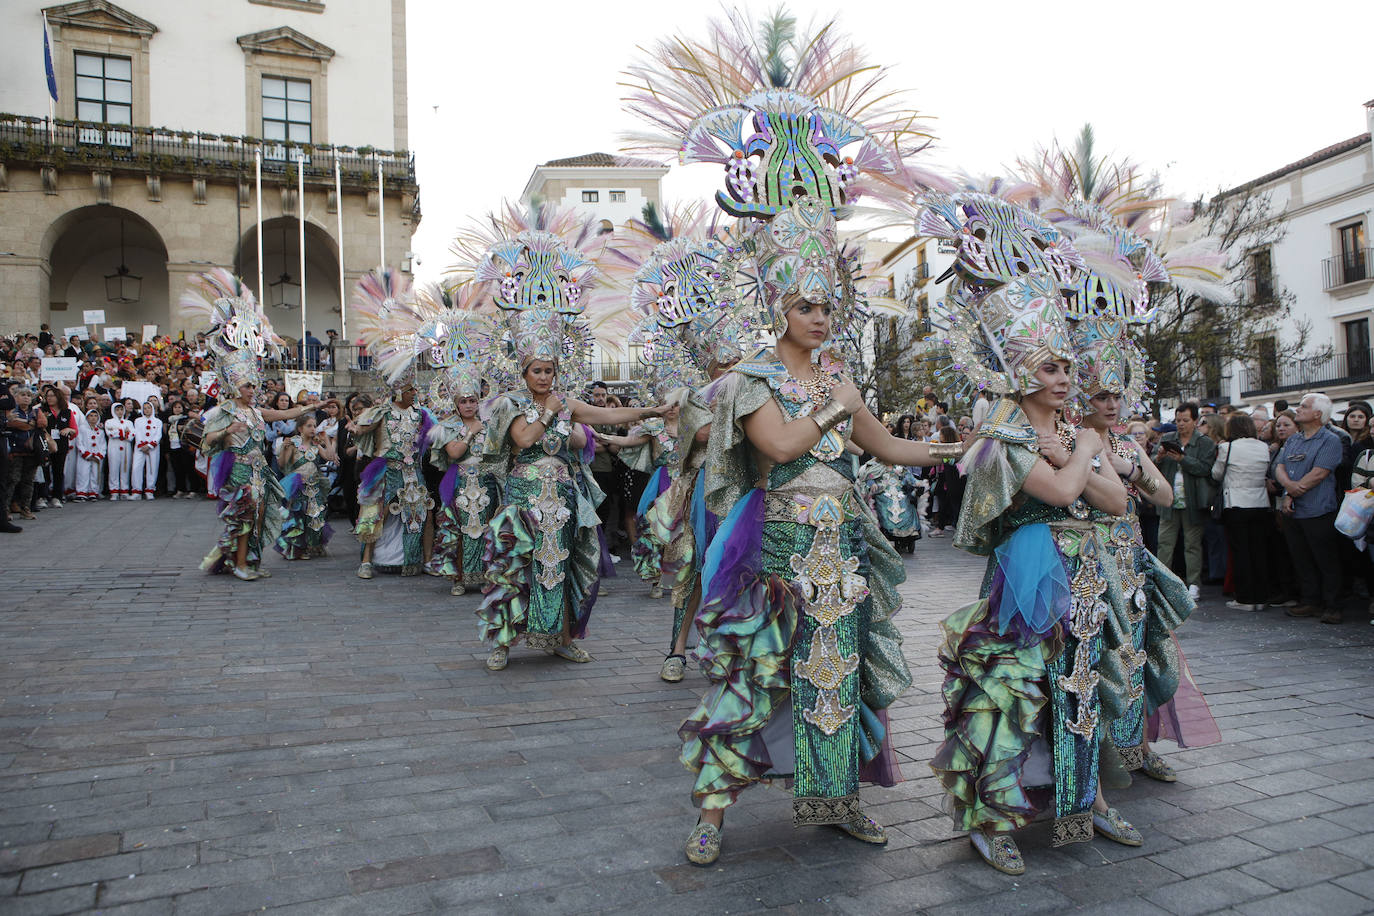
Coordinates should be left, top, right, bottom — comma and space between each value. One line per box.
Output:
0, 0, 419, 347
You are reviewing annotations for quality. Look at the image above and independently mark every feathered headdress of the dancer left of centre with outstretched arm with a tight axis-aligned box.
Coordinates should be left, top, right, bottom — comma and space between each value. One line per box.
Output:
451, 203, 606, 389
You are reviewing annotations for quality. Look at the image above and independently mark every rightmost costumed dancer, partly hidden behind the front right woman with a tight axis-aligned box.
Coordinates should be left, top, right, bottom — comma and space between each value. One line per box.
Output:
1022, 148, 1234, 787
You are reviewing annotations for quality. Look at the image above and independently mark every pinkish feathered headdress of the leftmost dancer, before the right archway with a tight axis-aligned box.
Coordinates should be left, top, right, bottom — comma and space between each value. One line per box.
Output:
177, 268, 280, 397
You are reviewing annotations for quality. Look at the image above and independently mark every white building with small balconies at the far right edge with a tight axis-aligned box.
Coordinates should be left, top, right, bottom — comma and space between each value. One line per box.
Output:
1227, 100, 1374, 404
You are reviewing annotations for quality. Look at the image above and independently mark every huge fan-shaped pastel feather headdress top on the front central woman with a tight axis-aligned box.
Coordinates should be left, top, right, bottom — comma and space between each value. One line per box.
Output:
625, 12, 930, 218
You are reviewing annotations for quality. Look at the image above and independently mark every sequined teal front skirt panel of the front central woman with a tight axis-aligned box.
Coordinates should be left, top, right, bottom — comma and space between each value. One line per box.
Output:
764, 513, 868, 825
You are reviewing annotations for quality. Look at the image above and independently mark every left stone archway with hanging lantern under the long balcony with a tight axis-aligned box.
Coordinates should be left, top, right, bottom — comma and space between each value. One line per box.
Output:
40, 205, 173, 340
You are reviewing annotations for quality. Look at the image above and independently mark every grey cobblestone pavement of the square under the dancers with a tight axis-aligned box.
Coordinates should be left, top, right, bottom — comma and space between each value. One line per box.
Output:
0, 501, 1374, 916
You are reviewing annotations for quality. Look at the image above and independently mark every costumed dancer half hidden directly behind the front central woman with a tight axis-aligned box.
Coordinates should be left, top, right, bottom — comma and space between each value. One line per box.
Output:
603, 205, 750, 683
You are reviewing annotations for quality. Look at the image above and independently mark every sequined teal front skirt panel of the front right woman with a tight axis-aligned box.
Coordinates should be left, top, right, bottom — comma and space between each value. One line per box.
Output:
1048, 529, 1107, 846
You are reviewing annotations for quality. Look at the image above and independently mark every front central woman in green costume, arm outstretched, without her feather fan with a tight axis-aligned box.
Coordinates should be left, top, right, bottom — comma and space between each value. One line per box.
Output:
679, 198, 962, 865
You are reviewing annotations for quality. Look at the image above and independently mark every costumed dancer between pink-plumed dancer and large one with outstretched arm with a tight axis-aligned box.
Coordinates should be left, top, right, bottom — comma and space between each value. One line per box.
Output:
416, 284, 500, 596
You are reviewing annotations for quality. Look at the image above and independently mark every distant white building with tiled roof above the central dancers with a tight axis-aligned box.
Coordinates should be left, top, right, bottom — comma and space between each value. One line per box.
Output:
521, 152, 668, 232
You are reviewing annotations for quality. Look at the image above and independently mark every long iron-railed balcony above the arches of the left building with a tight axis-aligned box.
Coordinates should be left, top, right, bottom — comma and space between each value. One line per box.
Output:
0, 114, 416, 194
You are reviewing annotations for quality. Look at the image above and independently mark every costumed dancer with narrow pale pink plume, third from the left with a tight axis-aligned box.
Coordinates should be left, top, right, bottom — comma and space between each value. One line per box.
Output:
349, 269, 434, 580
